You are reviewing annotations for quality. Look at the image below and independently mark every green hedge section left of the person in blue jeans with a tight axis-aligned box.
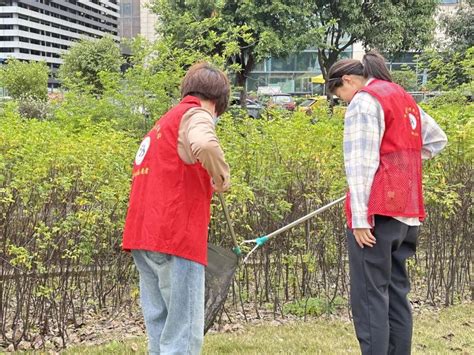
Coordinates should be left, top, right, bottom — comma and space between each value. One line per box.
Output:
0, 109, 136, 345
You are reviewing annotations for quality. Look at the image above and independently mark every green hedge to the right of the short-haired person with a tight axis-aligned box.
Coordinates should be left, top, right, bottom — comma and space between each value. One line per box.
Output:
211, 104, 474, 309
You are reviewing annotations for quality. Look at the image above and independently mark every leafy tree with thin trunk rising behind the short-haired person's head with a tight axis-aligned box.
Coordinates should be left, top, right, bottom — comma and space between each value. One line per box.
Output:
152, 0, 319, 103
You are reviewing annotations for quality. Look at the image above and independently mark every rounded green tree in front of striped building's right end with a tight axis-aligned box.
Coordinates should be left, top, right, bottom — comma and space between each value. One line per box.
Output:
59, 37, 124, 95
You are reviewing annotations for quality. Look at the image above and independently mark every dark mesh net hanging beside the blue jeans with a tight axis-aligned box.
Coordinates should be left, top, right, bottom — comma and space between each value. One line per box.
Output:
204, 244, 238, 334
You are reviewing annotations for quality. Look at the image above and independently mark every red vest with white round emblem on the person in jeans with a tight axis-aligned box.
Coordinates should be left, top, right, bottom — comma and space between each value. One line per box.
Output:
122, 96, 212, 265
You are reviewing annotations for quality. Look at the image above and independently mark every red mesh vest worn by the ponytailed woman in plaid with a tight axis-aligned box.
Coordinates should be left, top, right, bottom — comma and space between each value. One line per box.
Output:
346, 80, 425, 228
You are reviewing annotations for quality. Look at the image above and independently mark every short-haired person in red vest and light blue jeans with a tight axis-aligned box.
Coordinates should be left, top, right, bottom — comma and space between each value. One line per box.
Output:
122, 63, 230, 354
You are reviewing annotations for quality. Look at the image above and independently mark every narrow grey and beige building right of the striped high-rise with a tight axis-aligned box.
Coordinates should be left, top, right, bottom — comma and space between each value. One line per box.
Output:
120, 0, 157, 41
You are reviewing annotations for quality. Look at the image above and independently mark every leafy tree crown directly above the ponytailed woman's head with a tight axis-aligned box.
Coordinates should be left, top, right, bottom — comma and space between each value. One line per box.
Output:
307, 0, 437, 78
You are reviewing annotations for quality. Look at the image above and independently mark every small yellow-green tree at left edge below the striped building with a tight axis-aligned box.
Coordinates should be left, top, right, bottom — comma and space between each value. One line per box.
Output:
0, 58, 49, 100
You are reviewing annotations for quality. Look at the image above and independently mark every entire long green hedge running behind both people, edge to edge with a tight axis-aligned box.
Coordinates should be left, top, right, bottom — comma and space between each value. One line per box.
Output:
0, 101, 474, 350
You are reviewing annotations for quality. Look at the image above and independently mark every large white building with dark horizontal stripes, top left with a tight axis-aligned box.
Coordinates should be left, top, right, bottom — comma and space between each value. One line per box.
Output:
0, 0, 120, 86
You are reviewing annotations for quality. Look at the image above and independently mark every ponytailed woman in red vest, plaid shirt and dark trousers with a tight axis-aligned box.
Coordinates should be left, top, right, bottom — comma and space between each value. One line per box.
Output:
328, 52, 447, 354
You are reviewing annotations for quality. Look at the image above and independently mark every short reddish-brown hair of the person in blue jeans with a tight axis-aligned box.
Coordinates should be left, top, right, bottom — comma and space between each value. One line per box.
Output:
181, 62, 230, 116
